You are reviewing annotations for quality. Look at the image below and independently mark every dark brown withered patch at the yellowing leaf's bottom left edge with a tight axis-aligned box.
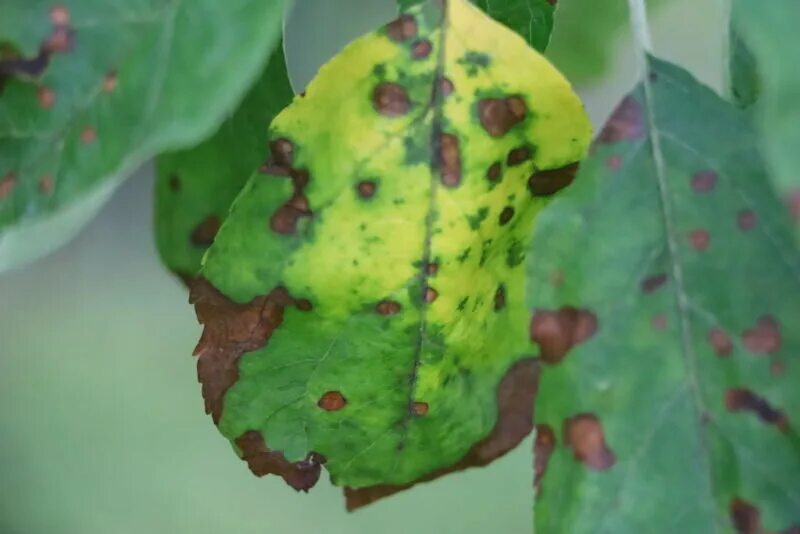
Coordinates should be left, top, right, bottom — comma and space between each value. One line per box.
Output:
236, 430, 325, 492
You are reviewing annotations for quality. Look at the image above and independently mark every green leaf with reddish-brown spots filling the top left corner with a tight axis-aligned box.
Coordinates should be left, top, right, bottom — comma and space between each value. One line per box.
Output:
0, 0, 285, 268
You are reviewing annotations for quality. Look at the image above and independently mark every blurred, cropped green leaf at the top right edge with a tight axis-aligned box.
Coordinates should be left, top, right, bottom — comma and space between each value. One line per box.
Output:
733, 0, 800, 238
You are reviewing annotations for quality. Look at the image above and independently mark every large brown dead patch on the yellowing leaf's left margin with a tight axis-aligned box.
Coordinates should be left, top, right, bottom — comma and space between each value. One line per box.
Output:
189, 278, 310, 423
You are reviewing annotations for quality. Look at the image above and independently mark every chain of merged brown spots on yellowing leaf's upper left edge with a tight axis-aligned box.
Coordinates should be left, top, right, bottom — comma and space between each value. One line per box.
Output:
262, 138, 311, 235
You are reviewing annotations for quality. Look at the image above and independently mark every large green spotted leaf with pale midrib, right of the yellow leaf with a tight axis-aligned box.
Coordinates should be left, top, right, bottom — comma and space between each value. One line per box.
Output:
528, 58, 800, 534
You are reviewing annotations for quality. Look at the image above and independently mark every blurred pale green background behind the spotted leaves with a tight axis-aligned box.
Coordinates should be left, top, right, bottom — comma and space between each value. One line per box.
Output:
0, 0, 725, 534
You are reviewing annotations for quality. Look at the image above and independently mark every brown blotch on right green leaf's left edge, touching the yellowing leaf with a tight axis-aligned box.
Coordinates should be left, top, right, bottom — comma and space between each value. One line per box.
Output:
530, 306, 597, 364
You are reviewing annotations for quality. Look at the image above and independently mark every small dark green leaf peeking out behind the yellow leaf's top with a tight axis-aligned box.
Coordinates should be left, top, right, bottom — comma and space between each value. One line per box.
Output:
398, 0, 556, 52
